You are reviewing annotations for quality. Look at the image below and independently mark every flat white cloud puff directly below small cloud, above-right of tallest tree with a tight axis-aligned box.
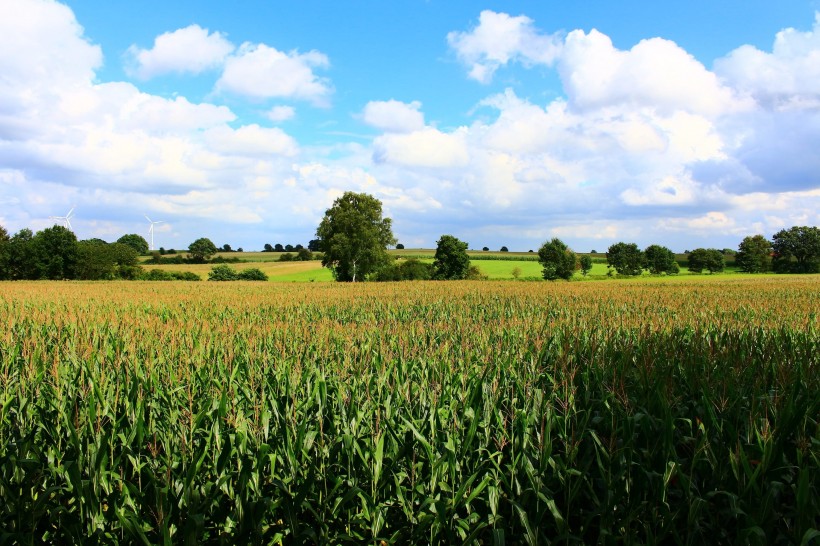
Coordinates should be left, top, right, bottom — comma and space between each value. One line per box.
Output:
373, 127, 470, 168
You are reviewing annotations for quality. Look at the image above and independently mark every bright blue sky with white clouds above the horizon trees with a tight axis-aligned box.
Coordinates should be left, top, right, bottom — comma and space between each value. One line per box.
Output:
0, 0, 820, 252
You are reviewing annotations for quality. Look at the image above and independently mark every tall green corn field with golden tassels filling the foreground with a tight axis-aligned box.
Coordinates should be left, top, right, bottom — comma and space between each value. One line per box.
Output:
0, 276, 820, 545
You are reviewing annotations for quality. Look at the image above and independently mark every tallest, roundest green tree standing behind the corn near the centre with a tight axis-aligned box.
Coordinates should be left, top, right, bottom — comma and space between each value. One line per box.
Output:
316, 192, 396, 282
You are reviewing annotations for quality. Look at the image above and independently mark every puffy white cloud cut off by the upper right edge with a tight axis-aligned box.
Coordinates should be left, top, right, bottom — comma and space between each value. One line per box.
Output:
715, 12, 820, 108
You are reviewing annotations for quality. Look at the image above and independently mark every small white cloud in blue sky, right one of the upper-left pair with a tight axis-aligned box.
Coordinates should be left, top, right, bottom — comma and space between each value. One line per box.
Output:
216, 43, 332, 104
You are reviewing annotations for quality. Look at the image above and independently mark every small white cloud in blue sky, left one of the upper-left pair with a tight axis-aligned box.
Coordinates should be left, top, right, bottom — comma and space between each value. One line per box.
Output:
127, 25, 235, 80
